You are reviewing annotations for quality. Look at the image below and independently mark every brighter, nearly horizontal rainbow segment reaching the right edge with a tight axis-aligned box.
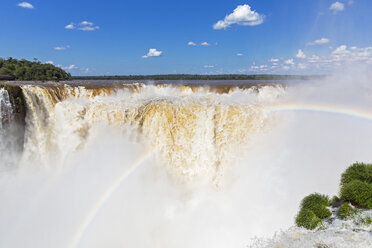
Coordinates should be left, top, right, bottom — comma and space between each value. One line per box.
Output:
267, 103, 372, 121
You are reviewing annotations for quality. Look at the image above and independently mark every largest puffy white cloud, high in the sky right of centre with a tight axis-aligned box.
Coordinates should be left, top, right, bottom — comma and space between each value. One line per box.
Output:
213, 4, 265, 29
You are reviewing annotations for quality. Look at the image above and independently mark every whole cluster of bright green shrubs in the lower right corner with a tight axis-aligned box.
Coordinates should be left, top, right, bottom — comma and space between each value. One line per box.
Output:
296, 162, 372, 229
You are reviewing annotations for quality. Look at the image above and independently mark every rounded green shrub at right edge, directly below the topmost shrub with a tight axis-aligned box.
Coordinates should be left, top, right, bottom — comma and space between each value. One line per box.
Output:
340, 180, 372, 209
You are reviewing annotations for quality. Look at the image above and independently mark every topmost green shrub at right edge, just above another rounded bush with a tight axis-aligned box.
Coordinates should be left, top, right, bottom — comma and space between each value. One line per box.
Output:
341, 162, 372, 186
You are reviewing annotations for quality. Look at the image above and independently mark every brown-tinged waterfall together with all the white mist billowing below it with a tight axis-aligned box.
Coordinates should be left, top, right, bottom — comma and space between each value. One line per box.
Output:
0, 75, 372, 248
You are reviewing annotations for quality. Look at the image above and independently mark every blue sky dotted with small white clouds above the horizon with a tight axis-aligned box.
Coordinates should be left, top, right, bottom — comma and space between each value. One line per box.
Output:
0, 0, 372, 75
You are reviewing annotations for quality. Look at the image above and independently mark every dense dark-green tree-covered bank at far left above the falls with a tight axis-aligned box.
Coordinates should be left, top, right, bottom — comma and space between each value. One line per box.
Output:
0, 58, 72, 81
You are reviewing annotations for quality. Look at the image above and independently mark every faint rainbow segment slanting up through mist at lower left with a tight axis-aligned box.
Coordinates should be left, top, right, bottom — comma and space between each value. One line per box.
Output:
67, 150, 154, 248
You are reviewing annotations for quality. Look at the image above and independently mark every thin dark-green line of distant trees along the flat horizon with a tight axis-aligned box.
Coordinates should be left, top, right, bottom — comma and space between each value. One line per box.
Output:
73, 74, 324, 80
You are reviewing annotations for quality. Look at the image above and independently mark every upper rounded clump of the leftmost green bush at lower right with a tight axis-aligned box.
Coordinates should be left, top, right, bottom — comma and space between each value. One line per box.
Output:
301, 193, 332, 219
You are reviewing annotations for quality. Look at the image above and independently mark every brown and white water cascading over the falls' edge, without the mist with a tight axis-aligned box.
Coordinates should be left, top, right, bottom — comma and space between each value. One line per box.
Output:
18, 85, 283, 183
